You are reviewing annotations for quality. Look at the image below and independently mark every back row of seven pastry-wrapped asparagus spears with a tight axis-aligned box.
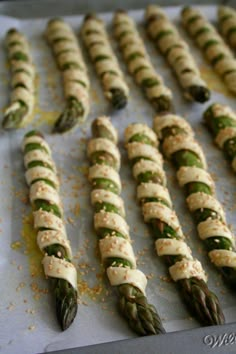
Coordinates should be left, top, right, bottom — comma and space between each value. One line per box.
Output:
3, 5, 236, 132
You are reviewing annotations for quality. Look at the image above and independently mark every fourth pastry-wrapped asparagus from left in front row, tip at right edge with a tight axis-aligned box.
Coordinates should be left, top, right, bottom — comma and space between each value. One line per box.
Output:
154, 115, 236, 288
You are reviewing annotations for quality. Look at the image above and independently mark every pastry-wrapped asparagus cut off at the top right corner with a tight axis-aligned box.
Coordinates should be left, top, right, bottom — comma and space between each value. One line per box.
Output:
218, 6, 236, 50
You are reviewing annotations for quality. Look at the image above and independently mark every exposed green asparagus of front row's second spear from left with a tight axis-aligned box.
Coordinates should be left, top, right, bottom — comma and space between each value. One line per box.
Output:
87, 117, 165, 335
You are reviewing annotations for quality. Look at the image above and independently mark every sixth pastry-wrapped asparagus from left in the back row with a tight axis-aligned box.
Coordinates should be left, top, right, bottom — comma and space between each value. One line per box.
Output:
181, 7, 236, 94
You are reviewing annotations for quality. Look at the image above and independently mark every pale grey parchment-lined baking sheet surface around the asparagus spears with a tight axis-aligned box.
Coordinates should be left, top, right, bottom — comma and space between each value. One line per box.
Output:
0, 6, 236, 354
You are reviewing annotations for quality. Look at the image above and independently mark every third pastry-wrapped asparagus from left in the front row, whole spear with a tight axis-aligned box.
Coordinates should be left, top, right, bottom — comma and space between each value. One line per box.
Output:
125, 123, 224, 325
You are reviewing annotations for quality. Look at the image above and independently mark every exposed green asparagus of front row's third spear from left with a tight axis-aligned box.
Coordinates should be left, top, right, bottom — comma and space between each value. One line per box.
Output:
126, 124, 224, 325
